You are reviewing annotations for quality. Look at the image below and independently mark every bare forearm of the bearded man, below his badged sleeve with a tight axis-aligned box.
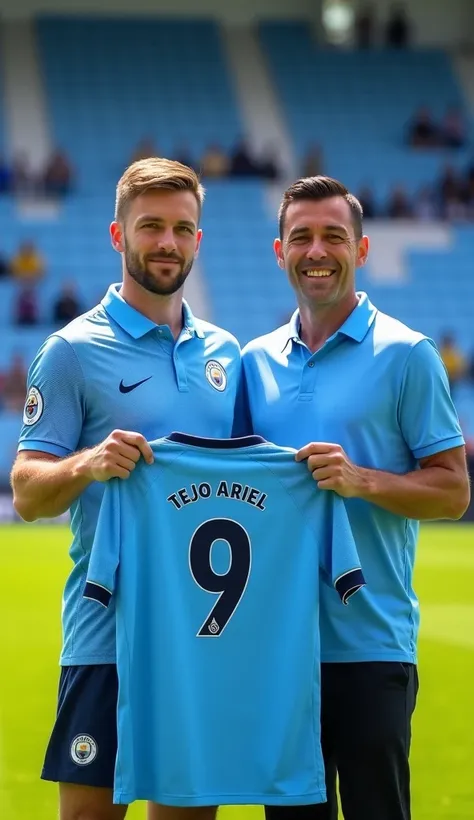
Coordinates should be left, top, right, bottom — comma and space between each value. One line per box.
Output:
11, 450, 92, 521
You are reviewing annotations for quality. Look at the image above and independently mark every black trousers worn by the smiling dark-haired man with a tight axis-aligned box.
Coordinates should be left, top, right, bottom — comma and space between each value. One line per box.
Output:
265, 661, 418, 820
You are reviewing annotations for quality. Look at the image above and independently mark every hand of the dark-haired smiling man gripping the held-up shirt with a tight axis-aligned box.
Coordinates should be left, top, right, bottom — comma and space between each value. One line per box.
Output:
296, 441, 366, 498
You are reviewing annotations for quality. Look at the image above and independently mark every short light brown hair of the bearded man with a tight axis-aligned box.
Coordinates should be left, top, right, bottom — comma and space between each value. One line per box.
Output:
115, 157, 205, 221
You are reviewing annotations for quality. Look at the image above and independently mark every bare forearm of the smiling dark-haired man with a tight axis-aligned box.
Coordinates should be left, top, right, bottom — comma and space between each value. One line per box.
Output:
359, 466, 469, 521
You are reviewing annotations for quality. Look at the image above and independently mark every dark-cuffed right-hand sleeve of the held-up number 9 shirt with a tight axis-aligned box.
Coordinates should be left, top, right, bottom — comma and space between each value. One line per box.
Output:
318, 490, 365, 604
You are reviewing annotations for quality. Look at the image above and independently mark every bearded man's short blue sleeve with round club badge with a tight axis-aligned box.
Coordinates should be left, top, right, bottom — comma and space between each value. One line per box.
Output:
18, 335, 85, 457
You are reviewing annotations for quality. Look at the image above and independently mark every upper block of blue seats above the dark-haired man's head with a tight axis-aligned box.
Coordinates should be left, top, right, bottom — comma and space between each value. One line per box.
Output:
259, 22, 470, 205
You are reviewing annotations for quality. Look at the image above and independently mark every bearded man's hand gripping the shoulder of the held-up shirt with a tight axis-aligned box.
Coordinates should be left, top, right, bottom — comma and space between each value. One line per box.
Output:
84, 430, 154, 481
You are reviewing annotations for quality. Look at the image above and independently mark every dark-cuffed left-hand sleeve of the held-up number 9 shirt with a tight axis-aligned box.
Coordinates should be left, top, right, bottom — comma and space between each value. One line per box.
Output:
83, 478, 122, 607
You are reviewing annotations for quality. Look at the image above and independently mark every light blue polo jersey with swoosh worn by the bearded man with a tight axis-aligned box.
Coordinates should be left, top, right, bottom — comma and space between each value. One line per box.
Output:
19, 285, 240, 665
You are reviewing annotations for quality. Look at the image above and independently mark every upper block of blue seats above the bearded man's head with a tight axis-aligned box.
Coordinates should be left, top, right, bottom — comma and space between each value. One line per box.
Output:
37, 17, 242, 188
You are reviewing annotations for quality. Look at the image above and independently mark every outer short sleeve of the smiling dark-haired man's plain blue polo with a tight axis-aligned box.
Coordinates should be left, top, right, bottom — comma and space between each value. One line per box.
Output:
398, 339, 464, 459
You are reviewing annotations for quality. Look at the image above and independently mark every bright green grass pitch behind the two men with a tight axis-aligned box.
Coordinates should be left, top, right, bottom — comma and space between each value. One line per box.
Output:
0, 524, 474, 820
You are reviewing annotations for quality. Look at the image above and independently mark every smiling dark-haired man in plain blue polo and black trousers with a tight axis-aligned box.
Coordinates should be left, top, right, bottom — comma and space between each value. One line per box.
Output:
234, 177, 469, 820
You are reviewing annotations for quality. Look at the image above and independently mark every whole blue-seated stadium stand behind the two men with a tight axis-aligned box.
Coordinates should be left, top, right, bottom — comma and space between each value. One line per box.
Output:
0, 16, 474, 494
